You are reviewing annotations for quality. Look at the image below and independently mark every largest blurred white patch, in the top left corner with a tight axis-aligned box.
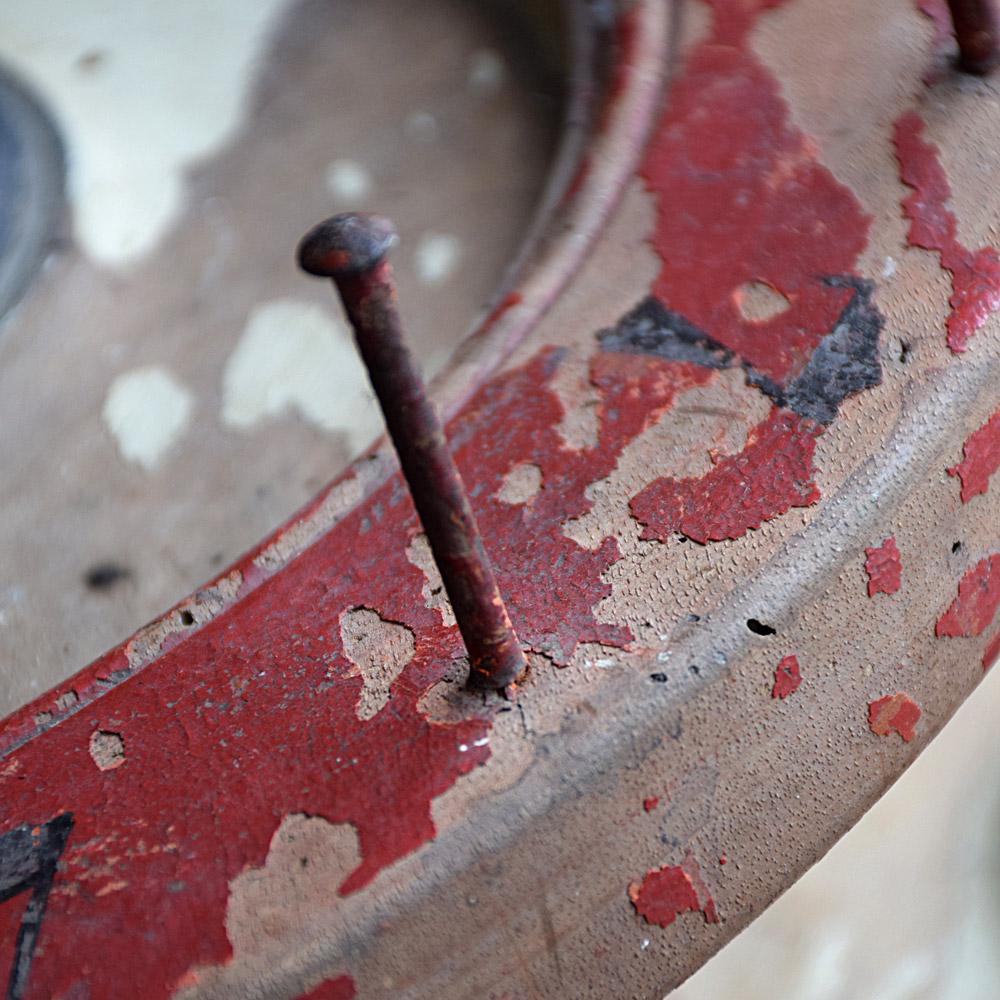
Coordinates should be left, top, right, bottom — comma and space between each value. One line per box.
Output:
0, 0, 289, 268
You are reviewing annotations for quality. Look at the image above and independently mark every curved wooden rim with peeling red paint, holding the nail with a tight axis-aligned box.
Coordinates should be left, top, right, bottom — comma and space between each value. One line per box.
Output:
0, 0, 1000, 998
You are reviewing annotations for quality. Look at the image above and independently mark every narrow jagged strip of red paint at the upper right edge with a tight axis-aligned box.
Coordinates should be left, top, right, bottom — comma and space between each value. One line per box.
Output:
894, 111, 1000, 354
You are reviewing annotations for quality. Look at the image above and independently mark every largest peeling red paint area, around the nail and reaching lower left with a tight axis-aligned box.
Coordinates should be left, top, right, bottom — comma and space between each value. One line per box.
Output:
0, 342, 716, 1000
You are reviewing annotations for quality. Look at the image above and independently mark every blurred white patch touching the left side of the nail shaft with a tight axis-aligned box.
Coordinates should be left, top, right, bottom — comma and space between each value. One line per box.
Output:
222, 299, 382, 452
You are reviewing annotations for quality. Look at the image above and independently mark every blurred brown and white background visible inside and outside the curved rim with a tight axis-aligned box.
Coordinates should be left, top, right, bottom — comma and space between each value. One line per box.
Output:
0, 0, 1000, 1000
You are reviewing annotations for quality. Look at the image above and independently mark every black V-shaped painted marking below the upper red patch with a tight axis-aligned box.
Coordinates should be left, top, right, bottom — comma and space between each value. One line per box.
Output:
597, 275, 884, 425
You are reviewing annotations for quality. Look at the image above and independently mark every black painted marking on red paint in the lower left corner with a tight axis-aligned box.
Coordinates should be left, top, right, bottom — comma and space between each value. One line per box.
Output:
0, 813, 73, 1000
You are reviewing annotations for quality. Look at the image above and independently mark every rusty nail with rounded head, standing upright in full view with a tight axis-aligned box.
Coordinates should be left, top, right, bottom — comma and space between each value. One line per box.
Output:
298, 213, 527, 688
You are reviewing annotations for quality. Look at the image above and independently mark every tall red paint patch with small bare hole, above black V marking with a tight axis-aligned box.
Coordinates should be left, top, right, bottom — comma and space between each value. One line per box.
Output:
643, 0, 870, 383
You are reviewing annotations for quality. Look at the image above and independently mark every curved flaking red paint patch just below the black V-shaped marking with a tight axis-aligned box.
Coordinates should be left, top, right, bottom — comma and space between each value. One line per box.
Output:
629, 407, 821, 544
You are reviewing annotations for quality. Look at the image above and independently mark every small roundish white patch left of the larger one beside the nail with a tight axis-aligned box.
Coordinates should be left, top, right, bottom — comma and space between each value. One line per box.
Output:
102, 365, 194, 469
